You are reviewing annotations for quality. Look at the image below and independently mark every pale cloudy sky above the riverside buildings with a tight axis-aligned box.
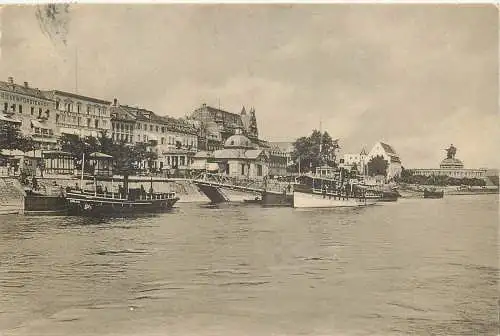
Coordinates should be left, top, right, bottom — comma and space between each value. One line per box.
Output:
0, 4, 500, 168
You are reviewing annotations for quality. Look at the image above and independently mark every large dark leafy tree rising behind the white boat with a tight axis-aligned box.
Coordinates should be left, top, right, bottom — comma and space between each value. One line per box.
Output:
292, 130, 339, 171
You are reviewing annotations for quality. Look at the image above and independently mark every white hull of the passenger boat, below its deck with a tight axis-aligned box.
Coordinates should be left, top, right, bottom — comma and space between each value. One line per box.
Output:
293, 191, 375, 208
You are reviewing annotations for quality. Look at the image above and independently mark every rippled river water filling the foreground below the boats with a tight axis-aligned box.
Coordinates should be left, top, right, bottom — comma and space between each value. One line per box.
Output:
0, 195, 499, 336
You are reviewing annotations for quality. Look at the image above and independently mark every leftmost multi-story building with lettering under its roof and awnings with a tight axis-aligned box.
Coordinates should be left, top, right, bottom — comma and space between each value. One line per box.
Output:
0, 77, 57, 149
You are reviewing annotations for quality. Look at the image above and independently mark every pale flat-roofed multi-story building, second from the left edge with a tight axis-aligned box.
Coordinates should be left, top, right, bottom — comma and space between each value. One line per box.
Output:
46, 90, 111, 137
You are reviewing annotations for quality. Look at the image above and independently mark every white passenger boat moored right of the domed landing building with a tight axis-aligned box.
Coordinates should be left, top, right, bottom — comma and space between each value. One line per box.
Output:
293, 175, 376, 208
